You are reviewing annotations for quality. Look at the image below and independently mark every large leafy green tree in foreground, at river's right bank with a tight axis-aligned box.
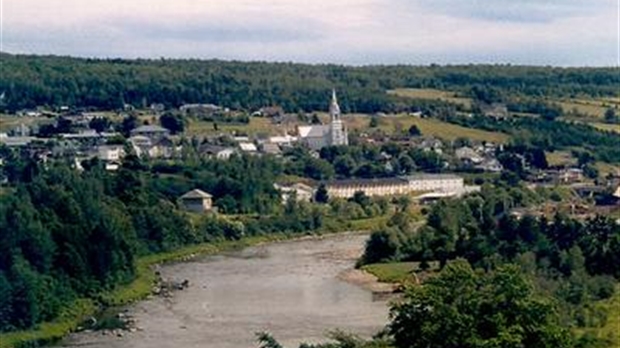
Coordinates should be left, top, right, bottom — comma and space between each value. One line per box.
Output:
389, 260, 571, 348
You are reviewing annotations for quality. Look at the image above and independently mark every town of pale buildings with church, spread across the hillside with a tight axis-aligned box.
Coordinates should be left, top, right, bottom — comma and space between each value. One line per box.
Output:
0, 90, 620, 217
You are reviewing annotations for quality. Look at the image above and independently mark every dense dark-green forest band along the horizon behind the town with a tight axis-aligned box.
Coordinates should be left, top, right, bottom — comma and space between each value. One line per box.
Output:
0, 53, 620, 112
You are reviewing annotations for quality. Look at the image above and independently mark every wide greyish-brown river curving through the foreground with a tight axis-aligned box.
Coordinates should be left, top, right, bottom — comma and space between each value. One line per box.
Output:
61, 234, 388, 348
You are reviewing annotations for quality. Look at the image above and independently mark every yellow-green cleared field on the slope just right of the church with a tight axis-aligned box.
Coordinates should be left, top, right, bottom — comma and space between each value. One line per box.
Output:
344, 115, 510, 143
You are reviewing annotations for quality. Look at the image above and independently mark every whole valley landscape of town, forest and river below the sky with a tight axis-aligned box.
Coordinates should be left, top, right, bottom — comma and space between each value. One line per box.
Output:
0, 53, 620, 348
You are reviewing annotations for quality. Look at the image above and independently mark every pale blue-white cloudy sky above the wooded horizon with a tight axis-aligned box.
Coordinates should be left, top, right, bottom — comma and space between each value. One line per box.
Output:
0, 0, 620, 66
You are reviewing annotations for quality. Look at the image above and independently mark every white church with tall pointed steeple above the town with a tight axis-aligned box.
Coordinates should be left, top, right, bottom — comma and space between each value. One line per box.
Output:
297, 90, 349, 150
